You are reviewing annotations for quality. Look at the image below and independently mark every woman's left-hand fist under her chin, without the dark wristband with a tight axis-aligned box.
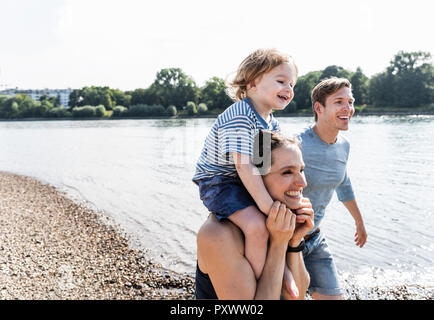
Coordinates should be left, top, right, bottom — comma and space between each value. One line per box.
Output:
266, 201, 295, 246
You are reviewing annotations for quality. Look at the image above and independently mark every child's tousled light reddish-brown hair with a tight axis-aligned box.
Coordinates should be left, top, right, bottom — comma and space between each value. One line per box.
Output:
226, 49, 298, 101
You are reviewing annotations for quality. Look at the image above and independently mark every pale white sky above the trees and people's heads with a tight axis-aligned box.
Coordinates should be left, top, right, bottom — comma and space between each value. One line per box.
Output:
0, 0, 434, 90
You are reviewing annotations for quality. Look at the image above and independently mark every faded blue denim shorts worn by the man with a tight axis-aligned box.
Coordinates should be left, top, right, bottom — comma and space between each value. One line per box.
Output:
303, 231, 342, 296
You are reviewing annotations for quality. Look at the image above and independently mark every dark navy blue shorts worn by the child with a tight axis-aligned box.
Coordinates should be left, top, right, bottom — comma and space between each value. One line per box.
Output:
198, 176, 256, 221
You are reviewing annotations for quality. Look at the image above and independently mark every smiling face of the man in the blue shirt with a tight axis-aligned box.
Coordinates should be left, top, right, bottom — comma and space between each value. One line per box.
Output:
318, 87, 354, 130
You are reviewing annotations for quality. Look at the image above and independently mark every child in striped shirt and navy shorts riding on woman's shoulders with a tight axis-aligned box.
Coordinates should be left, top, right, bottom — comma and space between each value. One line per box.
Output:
193, 49, 298, 279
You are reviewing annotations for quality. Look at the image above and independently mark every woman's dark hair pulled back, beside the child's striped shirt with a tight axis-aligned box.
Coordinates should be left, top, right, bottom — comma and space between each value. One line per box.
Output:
253, 130, 301, 175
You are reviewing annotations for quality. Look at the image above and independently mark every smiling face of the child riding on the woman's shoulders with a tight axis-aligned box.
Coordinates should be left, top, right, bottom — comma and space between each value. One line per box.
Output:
247, 63, 296, 111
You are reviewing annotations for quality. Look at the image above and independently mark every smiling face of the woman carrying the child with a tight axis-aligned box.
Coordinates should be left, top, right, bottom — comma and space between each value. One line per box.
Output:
263, 144, 307, 209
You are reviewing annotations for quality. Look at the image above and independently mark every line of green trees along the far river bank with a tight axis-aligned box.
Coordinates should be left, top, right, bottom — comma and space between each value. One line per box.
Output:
0, 51, 434, 119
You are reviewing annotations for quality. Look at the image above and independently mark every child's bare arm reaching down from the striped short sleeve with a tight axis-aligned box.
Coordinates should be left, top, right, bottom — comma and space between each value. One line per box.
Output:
232, 152, 274, 215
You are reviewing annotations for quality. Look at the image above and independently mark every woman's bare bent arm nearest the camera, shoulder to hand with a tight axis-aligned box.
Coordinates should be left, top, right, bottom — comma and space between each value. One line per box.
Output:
197, 202, 295, 300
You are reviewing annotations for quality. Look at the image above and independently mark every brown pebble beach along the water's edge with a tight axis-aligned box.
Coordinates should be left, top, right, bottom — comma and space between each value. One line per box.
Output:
0, 172, 434, 300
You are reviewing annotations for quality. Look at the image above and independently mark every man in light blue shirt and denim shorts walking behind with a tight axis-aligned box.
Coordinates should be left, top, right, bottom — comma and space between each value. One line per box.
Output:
298, 78, 367, 300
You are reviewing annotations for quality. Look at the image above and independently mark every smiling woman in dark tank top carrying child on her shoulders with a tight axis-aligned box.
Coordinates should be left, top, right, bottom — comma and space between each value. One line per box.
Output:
196, 131, 313, 300
